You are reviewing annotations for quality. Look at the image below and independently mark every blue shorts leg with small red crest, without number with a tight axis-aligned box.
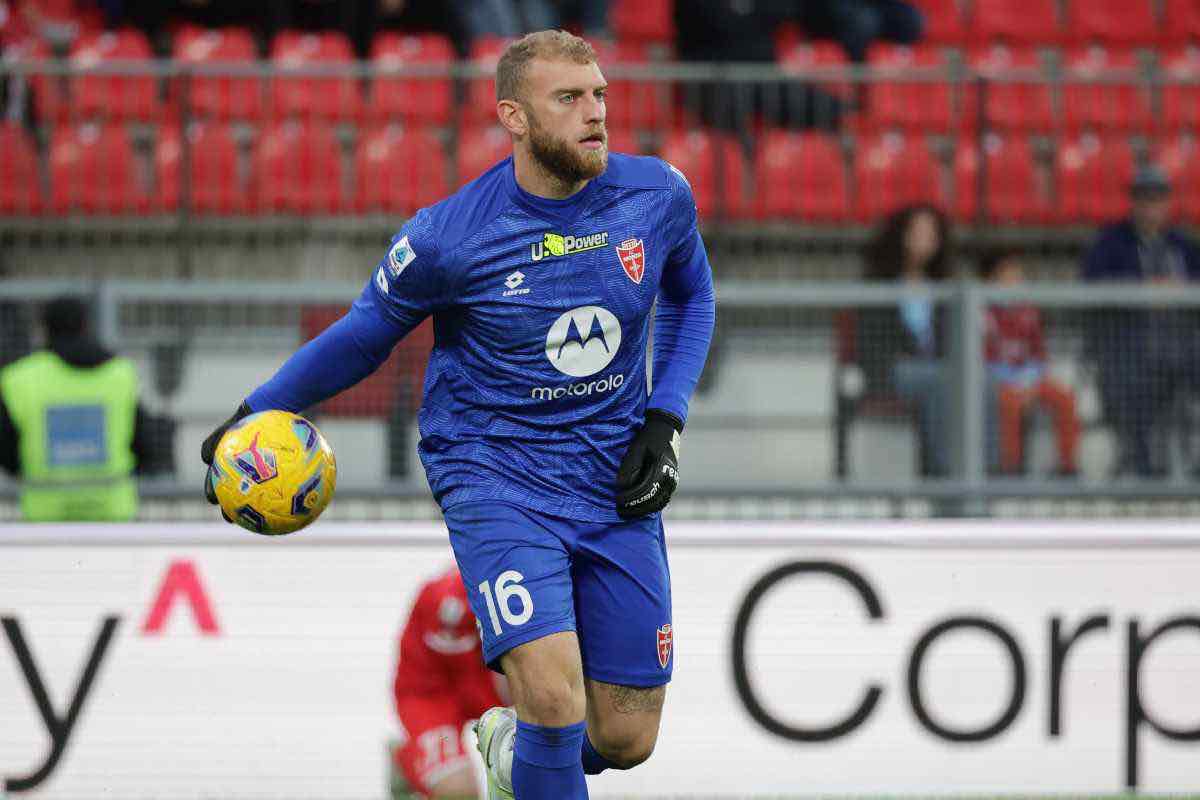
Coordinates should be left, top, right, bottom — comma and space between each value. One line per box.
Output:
571, 515, 674, 687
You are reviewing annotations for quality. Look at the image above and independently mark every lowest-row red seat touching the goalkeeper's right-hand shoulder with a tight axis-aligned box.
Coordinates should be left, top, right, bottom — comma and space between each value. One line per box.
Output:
661, 131, 746, 219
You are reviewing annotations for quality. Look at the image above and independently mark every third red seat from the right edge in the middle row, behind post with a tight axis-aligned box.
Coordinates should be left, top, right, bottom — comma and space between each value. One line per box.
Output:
964, 43, 1055, 131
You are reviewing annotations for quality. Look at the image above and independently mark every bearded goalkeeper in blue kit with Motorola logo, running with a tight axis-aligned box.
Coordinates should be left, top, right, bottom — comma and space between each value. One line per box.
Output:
202, 31, 715, 800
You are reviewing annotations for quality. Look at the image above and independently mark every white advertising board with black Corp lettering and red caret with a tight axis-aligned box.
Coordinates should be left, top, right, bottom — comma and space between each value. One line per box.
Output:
0, 522, 1200, 800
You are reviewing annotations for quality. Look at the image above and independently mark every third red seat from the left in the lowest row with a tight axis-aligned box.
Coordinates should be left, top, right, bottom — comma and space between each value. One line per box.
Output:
155, 122, 251, 215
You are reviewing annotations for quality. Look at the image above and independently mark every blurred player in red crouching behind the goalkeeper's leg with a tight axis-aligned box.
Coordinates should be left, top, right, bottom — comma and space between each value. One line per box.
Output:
392, 567, 508, 800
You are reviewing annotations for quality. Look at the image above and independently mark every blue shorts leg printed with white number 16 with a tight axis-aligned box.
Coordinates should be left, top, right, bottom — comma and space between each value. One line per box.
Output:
445, 503, 576, 670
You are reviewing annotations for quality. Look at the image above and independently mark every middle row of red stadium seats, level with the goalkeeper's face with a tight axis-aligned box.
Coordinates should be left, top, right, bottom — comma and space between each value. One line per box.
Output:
18, 28, 1200, 131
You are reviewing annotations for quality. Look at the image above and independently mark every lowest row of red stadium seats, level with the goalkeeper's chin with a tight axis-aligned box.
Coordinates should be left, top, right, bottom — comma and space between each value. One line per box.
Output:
9, 117, 1200, 224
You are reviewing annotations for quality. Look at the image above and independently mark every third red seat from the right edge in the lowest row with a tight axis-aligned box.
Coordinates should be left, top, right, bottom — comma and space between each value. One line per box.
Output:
954, 134, 1051, 223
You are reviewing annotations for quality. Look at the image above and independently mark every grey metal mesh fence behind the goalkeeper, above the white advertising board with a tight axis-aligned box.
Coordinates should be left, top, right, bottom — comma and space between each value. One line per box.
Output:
0, 281, 1200, 518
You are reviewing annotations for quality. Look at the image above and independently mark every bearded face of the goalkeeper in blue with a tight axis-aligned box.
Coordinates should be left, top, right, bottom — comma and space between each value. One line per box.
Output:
524, 59, 608, 184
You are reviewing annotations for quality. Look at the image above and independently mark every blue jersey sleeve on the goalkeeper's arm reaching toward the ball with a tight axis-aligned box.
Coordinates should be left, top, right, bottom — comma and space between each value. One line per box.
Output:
246, 210, 446, 411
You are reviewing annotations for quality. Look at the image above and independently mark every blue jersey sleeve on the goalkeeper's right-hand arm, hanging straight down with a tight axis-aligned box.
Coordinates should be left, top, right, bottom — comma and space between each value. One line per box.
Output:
647, 164, 716, 422
